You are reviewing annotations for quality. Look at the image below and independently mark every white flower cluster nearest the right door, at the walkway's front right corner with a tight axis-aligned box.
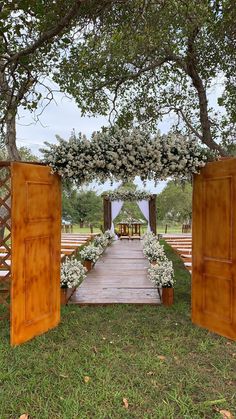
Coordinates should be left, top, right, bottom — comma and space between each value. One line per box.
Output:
148, 260, 174, 288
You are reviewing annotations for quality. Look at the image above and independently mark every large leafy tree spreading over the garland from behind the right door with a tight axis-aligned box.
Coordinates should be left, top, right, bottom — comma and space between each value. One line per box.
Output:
55, 0, 236, 155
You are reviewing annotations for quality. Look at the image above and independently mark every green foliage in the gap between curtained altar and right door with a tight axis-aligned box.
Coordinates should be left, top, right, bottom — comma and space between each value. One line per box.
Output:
157, 181, 192, 223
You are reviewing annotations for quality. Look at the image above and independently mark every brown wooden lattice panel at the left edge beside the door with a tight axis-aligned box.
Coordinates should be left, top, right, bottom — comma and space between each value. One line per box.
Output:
0, 165, 11, 319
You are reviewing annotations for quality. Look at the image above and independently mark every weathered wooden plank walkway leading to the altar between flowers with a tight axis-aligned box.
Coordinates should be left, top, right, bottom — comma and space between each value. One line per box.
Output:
70, 240, 160, 305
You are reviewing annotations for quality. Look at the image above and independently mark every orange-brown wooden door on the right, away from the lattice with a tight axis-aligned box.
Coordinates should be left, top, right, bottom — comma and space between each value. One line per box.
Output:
192, 159, 236, 339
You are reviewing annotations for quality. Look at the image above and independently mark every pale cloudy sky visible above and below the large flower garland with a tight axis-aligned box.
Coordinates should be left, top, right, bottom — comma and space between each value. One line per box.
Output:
16, 84, 170, 193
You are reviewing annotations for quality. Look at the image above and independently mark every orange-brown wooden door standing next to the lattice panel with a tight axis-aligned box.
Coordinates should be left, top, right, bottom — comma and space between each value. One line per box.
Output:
11, 162, 61, 345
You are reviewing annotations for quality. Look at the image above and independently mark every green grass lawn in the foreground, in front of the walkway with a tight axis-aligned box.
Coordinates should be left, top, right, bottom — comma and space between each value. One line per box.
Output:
0, 244, 236, 419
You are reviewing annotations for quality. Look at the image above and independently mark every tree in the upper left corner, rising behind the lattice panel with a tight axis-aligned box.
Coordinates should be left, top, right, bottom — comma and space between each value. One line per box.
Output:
0, 0, 97, 160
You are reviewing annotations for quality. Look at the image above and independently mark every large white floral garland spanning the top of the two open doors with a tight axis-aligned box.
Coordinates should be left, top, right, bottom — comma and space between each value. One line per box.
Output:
41, 128, 214, 184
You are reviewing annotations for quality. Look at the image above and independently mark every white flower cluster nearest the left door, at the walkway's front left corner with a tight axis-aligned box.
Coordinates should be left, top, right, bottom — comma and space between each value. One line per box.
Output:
61, 257, 87, 288
